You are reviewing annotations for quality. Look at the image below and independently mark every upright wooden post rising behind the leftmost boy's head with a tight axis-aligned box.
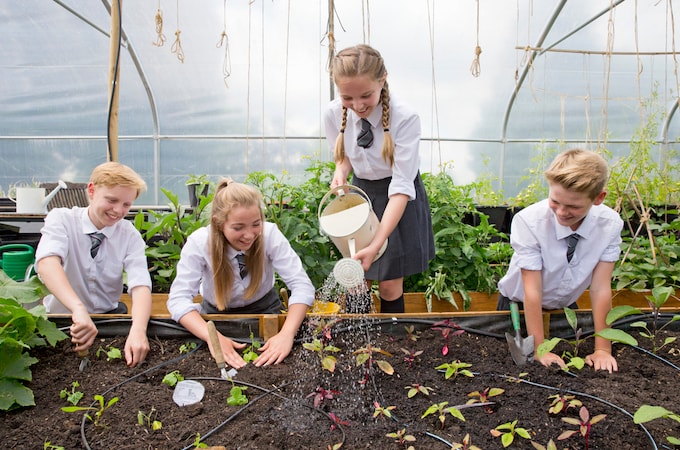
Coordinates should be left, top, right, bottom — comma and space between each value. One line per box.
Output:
107, 0, 123, 161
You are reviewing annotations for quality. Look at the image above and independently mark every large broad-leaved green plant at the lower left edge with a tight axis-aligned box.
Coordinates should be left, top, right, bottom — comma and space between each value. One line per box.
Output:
0, 271, 68, 411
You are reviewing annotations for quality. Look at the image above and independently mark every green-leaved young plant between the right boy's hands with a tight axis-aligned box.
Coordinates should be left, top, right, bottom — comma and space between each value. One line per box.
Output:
536, 307, 638, 371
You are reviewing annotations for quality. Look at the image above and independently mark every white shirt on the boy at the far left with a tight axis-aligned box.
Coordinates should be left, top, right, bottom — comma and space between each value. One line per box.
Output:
35, 206, 151, 314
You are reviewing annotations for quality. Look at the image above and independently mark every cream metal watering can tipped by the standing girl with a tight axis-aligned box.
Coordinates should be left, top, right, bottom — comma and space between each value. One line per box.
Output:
318, 185, 387, 288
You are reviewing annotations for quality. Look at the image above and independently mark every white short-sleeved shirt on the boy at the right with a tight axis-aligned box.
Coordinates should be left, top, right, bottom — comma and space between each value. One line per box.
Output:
498, 199, 623, 309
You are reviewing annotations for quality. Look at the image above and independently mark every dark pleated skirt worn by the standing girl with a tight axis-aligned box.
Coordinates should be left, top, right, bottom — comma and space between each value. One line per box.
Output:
352, 173, 434, 280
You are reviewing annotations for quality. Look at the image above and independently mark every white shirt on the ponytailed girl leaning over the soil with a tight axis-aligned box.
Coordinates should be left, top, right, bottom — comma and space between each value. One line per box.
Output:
167, 222, 314, 322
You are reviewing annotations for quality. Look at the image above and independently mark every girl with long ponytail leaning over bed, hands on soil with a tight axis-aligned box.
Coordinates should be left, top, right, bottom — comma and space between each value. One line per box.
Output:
167, 179, 314, 369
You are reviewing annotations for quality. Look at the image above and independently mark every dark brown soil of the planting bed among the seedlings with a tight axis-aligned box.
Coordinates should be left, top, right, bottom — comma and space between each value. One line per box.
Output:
0, 320, 680, 450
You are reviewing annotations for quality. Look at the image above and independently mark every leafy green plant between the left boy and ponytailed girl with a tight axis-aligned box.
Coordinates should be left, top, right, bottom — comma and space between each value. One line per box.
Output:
134, 188, 209, 293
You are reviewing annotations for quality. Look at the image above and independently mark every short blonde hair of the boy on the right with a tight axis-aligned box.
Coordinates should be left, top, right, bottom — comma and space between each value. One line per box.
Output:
544, 148, 609, 200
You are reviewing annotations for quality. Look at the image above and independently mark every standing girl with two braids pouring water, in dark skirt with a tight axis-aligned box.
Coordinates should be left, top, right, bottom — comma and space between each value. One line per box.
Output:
324, 45, 434, 313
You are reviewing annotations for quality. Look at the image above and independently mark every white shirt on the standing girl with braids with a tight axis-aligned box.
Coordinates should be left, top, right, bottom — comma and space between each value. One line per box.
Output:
324, 97, 420, 200
